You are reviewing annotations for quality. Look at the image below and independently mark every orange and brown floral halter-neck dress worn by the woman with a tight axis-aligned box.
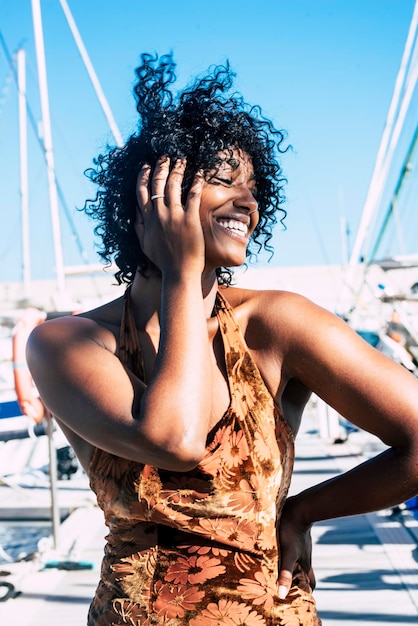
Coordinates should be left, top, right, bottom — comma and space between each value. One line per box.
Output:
88, 290, 321, 626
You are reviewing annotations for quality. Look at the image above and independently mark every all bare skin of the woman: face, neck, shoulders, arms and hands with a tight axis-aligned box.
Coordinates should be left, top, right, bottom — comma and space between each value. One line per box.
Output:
28, 150, 418, 597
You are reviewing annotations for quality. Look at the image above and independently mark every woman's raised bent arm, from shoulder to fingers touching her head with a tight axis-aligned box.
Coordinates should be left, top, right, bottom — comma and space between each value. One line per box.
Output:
27, 160, 212, 471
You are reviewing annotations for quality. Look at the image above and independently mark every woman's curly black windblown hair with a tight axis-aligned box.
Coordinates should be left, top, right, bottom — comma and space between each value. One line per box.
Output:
84, 53, 288, 284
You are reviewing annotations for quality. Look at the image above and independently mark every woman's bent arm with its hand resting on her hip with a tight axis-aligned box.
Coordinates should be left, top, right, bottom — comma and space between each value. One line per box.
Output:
266, 294, 418, 595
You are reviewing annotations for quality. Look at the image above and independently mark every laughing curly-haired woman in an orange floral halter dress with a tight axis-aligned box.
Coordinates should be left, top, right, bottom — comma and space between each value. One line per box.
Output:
28, 55, 418, 626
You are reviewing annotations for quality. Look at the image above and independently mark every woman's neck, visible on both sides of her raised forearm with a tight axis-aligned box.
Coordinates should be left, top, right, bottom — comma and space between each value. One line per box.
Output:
131, 272, 218, 329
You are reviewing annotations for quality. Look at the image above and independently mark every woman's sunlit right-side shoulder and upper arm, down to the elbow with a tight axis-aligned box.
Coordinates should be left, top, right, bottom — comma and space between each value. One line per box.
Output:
225, 289, 418, 445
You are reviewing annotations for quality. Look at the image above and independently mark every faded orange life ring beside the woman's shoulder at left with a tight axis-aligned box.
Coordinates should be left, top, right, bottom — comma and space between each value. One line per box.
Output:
13, 308, 46, 424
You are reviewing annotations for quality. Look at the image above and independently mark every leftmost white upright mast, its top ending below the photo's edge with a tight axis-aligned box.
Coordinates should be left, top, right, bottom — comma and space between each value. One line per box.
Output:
16, 48, 31, 298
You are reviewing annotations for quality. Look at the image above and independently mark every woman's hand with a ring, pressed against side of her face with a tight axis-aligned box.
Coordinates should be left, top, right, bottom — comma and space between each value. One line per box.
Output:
135, 157, 205, 276
